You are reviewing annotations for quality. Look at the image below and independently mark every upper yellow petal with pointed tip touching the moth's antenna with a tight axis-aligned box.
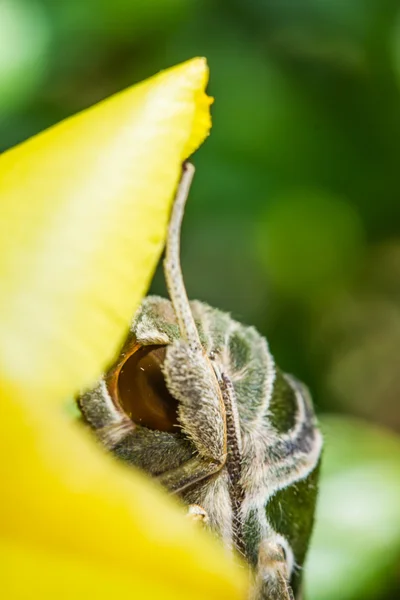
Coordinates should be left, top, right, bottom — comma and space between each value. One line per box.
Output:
0, 58, 210, 401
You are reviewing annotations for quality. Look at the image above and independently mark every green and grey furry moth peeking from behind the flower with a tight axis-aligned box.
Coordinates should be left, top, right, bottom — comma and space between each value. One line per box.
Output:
78, 163, 322, 600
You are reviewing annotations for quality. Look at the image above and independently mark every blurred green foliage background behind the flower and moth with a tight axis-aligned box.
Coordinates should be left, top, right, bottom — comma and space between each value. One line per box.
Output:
0, 0, 400, 600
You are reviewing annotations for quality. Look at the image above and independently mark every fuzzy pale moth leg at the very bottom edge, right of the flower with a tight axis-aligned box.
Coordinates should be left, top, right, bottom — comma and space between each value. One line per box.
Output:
252, 540, 294, 600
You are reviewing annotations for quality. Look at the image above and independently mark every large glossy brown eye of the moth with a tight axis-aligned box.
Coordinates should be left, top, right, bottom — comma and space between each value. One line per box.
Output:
116, 346, 178, 431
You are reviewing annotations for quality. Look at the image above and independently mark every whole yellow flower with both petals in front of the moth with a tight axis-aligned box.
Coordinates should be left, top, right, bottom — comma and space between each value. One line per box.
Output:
0, 59, 247, 600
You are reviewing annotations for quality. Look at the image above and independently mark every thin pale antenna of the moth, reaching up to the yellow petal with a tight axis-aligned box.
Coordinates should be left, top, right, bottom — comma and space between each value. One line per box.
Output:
164, 163, 201, 350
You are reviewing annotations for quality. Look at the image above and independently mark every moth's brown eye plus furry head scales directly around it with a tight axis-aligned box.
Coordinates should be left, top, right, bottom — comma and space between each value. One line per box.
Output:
78, 296, 193, 475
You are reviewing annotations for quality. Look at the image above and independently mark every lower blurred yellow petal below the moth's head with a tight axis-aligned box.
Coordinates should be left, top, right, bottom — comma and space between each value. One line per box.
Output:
0, 386, 246, 600
